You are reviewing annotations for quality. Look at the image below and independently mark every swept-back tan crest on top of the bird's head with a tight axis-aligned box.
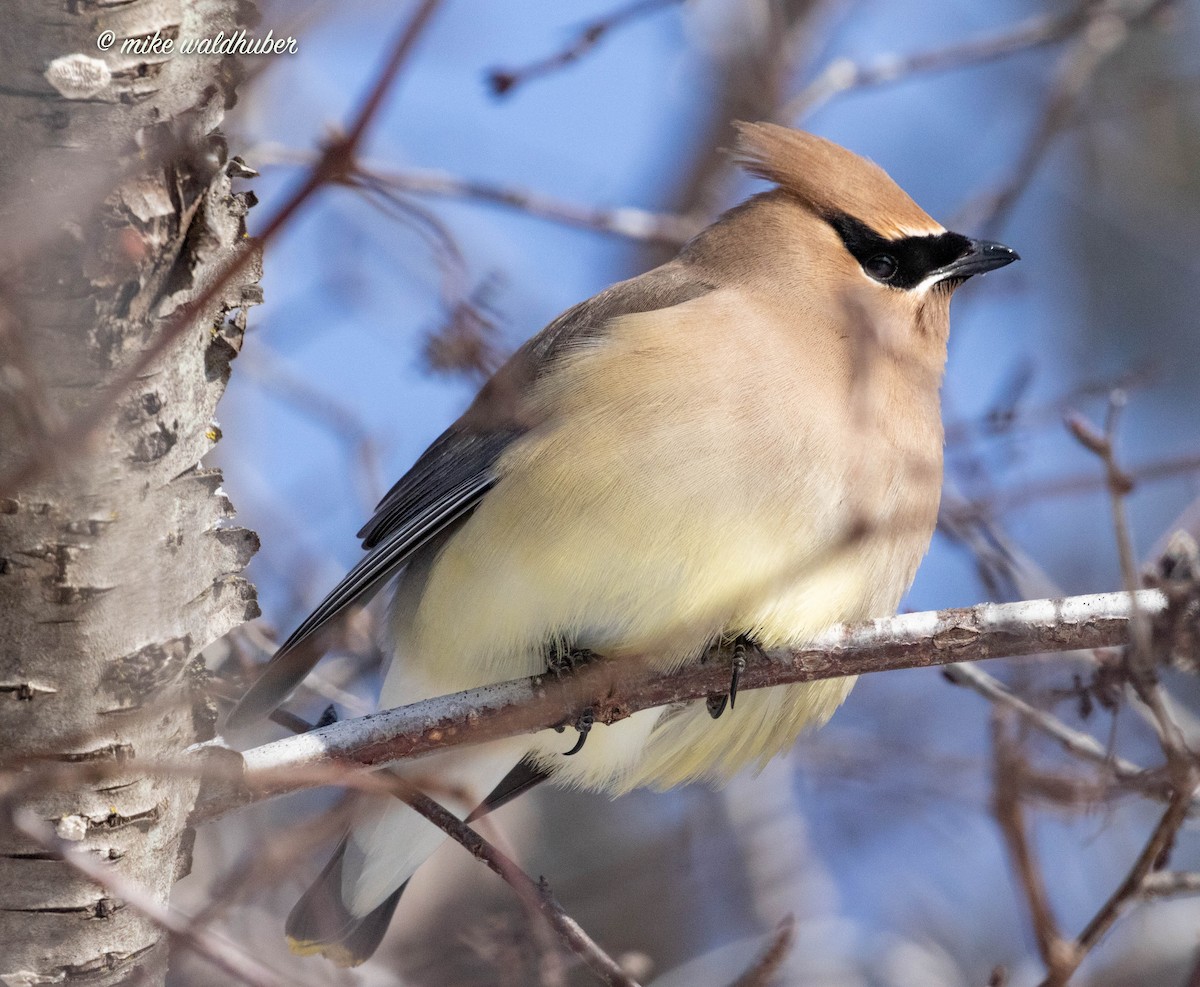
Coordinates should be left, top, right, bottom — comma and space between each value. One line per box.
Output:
734, 122, 944, 238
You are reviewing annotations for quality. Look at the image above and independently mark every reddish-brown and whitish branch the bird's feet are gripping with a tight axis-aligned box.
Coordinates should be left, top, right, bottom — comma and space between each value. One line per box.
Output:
197, 590, 1166, 819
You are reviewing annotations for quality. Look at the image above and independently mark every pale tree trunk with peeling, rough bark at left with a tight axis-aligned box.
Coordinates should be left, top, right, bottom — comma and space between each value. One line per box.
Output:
0, 0, 259, 987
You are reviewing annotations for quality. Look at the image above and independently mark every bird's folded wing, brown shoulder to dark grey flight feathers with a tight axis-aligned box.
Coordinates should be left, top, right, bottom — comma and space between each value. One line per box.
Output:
227, 261, 713, 726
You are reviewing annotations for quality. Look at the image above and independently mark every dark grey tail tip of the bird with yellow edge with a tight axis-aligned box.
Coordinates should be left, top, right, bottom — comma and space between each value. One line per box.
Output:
284, 838, 408, 967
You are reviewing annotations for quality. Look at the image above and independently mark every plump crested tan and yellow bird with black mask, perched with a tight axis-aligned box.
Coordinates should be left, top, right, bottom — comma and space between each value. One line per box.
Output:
228, 122, 1019, 965
